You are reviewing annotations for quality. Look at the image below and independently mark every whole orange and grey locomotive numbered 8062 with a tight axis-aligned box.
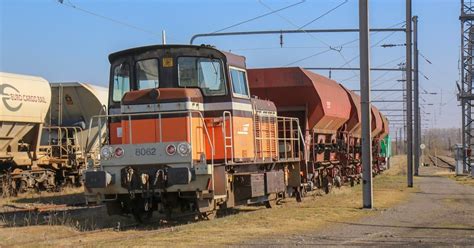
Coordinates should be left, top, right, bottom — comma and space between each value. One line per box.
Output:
85, 45, 300, 221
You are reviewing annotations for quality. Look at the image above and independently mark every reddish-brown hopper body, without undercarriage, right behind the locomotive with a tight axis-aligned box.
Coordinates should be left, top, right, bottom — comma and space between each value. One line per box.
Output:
248, 67, 351, 133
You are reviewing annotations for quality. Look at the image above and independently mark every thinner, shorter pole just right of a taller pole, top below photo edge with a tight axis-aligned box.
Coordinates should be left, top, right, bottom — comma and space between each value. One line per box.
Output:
413, 16, 421, 176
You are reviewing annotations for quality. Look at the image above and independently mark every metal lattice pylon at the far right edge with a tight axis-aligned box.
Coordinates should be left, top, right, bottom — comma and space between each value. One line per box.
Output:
459, 0, 474, 175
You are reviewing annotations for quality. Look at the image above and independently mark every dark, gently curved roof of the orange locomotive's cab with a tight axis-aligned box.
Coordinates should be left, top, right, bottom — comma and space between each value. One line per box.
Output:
109, 44, 245, 68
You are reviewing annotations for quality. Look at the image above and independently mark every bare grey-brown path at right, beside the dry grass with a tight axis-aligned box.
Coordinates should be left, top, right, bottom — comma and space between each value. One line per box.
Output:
247, 167, 474, 247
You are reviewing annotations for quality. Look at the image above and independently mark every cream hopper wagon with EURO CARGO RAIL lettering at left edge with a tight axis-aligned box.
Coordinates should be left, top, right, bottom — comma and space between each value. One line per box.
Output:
0, 72, 54, 195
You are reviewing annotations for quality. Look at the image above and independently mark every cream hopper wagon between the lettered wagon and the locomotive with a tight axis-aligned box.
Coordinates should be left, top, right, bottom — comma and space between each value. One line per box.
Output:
40, 82, 108, 185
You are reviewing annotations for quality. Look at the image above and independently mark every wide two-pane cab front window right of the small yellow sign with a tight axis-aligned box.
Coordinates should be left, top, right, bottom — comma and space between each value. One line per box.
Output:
178, 57, 226, 96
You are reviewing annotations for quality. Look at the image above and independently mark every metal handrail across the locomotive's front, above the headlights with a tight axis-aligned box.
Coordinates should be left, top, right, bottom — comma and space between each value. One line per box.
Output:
88, 110, 215, 165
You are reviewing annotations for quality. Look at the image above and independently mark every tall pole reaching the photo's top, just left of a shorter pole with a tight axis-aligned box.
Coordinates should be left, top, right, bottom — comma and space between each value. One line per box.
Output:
405, 0, 413, 188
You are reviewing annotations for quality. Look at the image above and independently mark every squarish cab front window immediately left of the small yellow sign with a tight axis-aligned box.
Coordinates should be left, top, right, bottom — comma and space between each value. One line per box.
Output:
135, 59, 159, 90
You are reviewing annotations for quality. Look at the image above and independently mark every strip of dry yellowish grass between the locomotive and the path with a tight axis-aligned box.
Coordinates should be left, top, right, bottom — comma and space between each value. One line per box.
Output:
0, 156, 415, 247
